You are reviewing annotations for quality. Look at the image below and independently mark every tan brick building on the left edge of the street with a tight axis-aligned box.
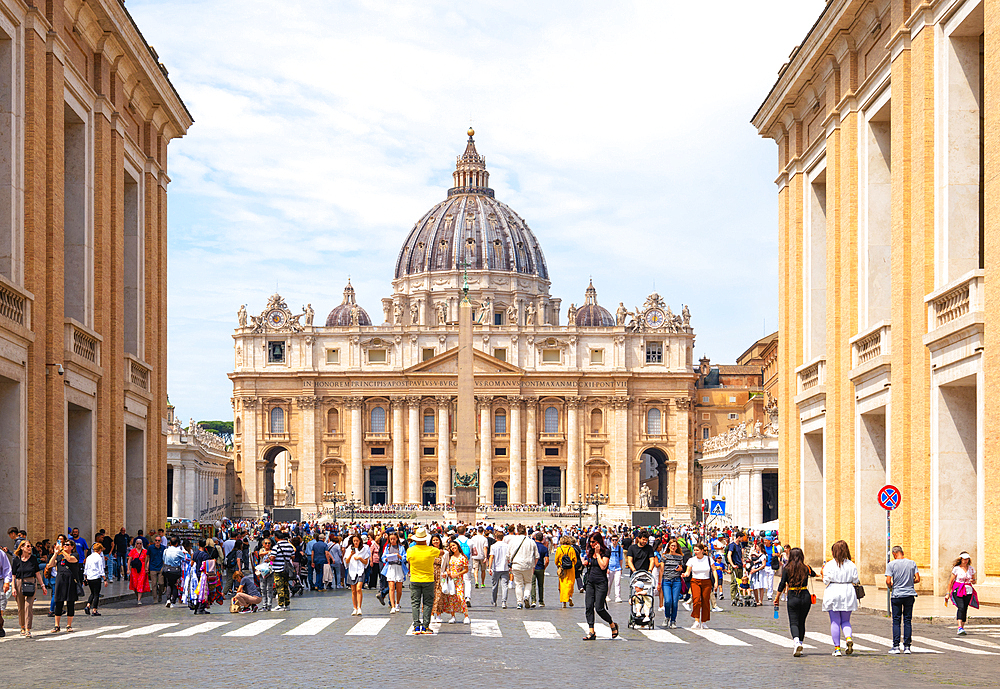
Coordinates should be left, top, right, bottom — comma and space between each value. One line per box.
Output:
0, 0, 192, 541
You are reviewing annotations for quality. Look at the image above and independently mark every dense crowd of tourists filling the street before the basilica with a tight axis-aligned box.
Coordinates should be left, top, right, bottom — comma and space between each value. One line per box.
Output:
0, 520, 978, 656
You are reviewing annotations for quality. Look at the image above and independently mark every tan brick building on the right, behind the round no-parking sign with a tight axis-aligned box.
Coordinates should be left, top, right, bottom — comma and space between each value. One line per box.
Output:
753, 0, 1000, 601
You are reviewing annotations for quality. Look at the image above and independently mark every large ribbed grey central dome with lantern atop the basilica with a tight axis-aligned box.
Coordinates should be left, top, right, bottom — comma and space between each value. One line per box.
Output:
396, 129, 549, 281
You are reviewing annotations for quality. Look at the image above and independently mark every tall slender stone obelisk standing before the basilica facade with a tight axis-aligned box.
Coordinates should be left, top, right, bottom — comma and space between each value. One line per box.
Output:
455, 258, 484, 524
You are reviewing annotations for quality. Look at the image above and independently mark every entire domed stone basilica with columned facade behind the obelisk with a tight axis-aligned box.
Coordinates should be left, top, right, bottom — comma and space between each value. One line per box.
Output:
230, 130, 697, 519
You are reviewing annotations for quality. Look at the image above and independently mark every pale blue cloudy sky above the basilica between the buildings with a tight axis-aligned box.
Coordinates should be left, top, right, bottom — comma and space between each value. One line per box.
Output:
128, 0, 825, 419
